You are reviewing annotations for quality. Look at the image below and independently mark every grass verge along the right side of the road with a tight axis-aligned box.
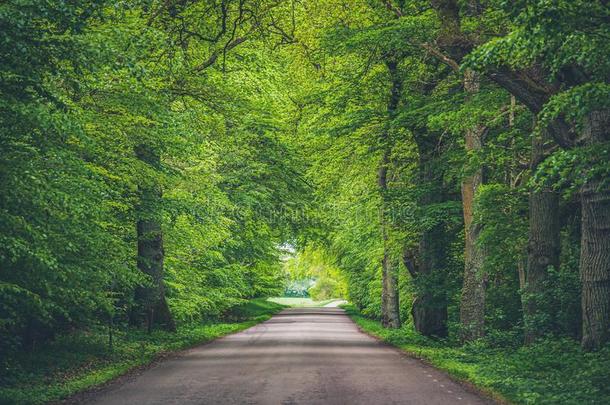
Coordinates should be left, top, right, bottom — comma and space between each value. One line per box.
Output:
342, 305, 610, 404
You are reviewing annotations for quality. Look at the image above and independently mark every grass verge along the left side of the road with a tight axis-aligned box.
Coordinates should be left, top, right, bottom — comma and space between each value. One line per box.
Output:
0, 299, 285, 404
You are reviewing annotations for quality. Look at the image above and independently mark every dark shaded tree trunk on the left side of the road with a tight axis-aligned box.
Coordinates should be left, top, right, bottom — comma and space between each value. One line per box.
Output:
136, 145, 176, 331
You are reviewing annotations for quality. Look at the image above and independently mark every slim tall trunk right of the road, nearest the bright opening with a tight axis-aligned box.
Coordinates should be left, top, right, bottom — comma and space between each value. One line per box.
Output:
377, 60, 402, 328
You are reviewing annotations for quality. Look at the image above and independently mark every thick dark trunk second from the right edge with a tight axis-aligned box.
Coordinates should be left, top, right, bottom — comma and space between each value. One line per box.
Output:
523, 128, 561, 344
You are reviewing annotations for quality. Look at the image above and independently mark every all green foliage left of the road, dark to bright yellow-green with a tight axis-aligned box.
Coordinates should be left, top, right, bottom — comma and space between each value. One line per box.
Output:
0, 1, 308, 354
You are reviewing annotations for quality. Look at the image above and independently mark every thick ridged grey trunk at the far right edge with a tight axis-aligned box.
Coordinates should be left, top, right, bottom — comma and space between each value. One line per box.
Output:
580, 110, 610, 351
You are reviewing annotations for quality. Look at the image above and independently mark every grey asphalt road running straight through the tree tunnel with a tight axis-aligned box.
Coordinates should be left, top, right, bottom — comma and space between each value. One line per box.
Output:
87, 308, 491, 405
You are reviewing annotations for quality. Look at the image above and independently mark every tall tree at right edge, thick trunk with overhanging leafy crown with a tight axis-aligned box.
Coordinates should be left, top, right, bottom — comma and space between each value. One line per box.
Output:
460, 1, 610, 350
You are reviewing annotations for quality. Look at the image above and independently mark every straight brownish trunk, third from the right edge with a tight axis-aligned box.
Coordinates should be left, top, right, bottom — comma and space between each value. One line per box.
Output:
460, 70, 486, 341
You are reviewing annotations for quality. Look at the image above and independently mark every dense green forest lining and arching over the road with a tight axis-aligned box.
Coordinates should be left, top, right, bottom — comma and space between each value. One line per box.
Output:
0, 0, 610, 403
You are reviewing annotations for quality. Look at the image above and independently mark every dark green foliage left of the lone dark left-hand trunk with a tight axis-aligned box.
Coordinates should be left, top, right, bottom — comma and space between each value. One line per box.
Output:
0, 2, 141, 352
